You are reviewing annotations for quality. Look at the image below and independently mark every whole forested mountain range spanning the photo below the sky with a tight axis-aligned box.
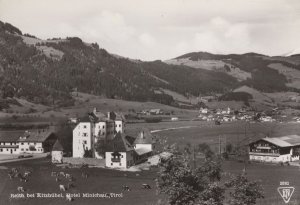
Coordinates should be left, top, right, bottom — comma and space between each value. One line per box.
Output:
0, 21, 300, 110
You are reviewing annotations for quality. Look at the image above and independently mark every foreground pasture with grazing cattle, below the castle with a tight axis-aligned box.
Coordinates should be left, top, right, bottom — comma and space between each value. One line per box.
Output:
0, 159, 158, 205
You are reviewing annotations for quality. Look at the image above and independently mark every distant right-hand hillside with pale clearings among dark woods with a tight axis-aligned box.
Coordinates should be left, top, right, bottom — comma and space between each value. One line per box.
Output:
165, 52, 300, 92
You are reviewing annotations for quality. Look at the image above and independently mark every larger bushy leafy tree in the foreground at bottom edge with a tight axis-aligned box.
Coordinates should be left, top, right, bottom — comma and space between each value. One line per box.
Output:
157, 156, 224, 205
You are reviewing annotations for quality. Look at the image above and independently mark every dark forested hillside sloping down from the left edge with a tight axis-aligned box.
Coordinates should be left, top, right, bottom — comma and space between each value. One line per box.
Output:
0, 22, 237, 108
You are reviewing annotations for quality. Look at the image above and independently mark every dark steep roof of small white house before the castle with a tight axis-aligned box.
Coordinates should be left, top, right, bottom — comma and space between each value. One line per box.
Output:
107, 132, 133, 152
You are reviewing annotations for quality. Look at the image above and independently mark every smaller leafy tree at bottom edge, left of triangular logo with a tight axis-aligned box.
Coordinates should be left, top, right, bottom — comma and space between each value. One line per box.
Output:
225, 174, 264, 205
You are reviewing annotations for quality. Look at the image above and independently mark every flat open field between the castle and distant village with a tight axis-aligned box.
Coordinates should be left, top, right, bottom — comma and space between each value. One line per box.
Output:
127, 121, 300, 151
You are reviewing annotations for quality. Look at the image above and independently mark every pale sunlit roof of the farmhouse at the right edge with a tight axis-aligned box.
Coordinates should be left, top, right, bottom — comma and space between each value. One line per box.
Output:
252, 135, 300, 147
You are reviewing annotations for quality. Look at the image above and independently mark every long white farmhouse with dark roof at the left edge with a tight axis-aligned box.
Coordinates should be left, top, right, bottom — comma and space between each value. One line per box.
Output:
0, 129, 57, 154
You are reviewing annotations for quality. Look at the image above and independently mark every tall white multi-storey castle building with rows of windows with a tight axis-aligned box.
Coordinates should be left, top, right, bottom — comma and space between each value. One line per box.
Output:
73, 108, 125, 158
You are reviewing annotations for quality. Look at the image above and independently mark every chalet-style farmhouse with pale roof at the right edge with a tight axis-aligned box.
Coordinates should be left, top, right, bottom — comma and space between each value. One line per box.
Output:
249, 135, 300, 162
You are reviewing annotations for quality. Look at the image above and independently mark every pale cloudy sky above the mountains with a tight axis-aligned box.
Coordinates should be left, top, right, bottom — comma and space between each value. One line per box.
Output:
0, 0, 300, 61
